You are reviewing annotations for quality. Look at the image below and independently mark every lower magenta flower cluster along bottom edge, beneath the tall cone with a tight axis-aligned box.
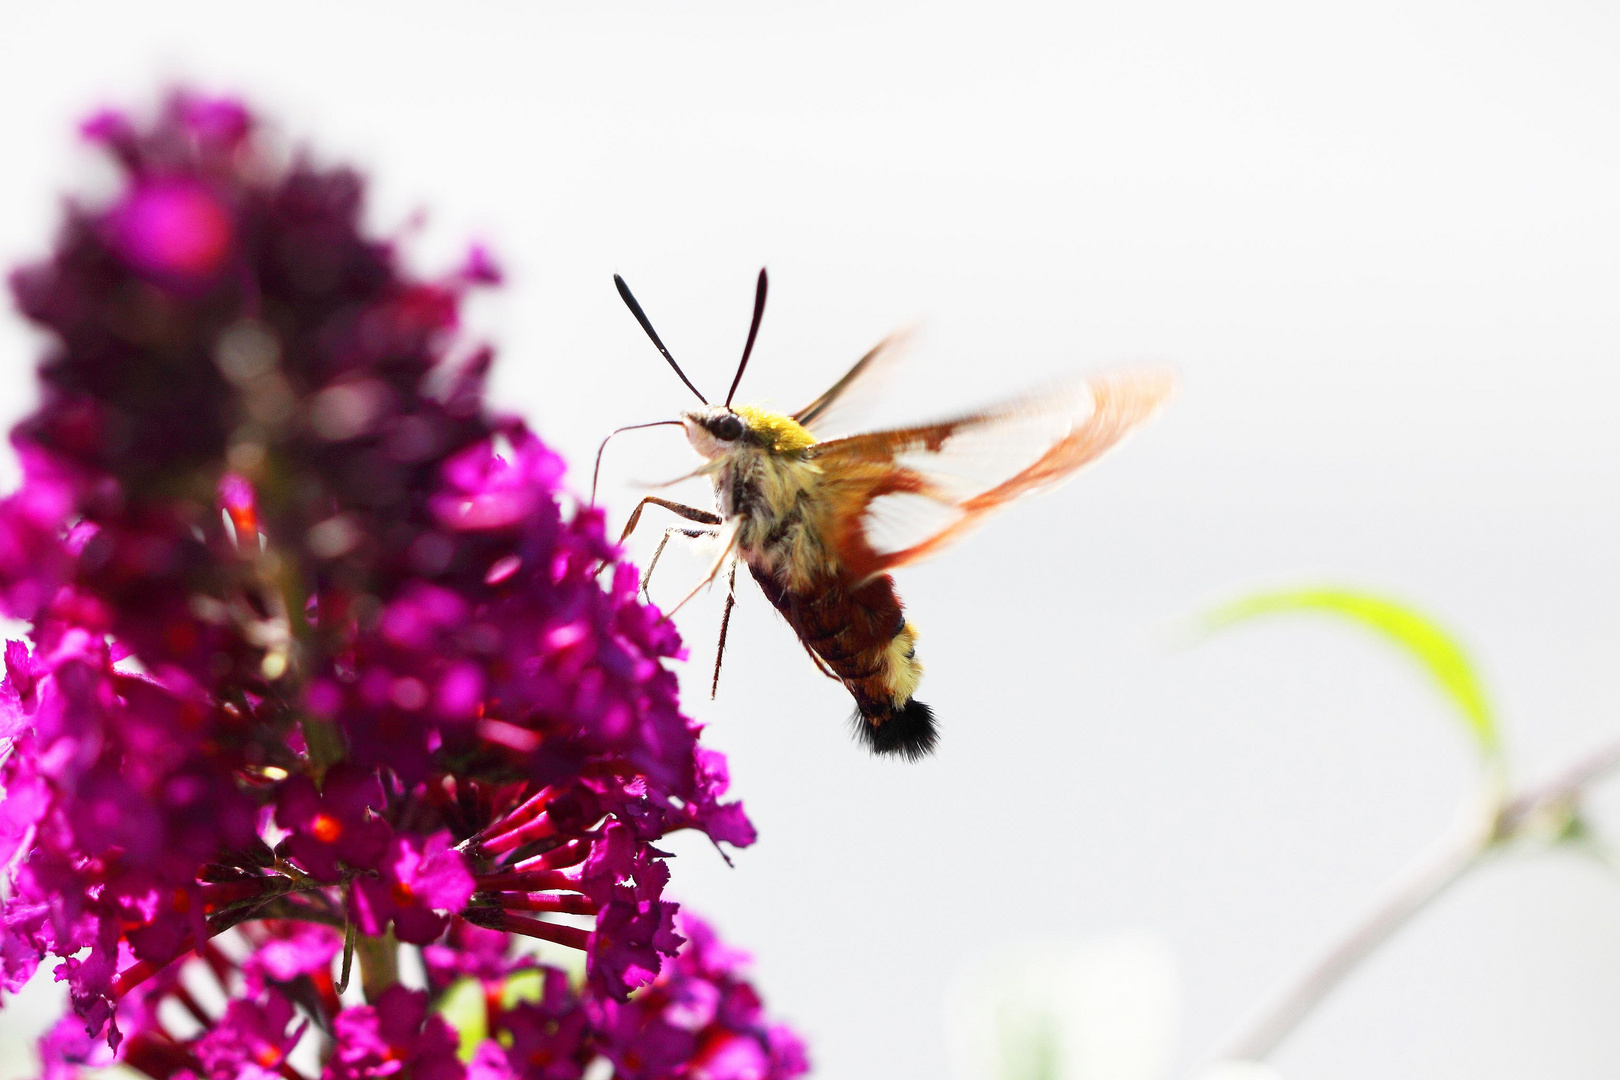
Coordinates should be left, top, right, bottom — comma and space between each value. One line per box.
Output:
31, 912, 808, 1080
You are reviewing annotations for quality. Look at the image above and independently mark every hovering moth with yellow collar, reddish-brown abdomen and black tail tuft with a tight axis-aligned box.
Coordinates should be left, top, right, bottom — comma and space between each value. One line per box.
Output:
591, 270, 1175, 761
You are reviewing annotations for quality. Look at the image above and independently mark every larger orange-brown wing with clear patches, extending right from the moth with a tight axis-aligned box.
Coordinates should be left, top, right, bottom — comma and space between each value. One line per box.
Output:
810, 368, 1176, 580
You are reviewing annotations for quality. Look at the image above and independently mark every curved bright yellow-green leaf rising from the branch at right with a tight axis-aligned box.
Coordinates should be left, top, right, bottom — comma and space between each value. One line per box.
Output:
1205, 588, 1502, 763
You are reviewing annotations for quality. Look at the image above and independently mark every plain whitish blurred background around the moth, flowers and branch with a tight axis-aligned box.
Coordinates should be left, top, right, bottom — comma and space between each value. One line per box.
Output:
0, 0, 1620, 1080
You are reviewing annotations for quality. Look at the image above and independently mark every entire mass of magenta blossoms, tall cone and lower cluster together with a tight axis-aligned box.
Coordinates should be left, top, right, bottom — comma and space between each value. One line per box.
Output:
0, 96, 805, 1080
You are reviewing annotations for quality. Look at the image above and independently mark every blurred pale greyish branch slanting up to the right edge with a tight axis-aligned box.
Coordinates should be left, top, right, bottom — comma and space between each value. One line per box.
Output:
1218, 738, 1620, 1061
